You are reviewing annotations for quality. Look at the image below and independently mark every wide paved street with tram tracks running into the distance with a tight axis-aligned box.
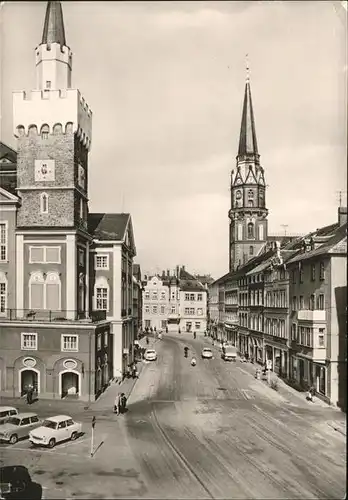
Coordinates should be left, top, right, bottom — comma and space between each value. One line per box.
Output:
1, 334, 346, 499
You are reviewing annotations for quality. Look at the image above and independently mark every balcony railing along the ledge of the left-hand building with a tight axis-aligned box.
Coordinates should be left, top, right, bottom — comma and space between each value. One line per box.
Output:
0, 309, 106, 323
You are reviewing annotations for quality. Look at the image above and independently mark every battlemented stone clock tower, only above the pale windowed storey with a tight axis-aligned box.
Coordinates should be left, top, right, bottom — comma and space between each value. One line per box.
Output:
13, 1, 92, 232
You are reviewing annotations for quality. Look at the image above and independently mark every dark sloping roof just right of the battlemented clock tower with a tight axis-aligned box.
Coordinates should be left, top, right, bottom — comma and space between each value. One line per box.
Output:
88, 213, 130, 241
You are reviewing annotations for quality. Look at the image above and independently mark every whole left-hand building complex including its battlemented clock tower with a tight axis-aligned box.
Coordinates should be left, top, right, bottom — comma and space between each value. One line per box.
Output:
0, 1, 142, 400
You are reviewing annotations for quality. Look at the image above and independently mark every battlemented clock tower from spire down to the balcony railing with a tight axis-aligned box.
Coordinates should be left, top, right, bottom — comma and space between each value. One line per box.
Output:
13, 1, 92, 318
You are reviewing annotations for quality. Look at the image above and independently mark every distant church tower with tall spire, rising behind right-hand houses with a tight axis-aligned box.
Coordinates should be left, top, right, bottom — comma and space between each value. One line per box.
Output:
228, 68, 268, 272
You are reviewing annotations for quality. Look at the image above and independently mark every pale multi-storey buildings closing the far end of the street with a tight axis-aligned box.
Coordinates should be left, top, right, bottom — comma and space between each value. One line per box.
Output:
142, 266, 213, 334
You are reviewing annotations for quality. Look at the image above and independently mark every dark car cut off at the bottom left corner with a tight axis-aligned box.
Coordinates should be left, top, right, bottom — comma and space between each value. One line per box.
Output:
0, 465, 42, 500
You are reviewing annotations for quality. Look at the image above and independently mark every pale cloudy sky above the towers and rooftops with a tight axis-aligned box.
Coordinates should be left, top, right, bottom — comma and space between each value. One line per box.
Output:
0, 1, 347, 278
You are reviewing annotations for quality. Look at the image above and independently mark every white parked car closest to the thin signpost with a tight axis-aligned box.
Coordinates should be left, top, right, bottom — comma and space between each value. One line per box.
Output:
29, 415, 82, 448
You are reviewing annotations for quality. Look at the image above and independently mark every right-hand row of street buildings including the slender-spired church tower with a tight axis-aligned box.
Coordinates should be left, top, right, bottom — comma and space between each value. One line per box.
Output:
208, 68, 347, 409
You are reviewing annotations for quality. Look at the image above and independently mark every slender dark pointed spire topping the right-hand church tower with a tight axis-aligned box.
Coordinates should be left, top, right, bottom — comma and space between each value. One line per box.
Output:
238, 62, 259, 156
